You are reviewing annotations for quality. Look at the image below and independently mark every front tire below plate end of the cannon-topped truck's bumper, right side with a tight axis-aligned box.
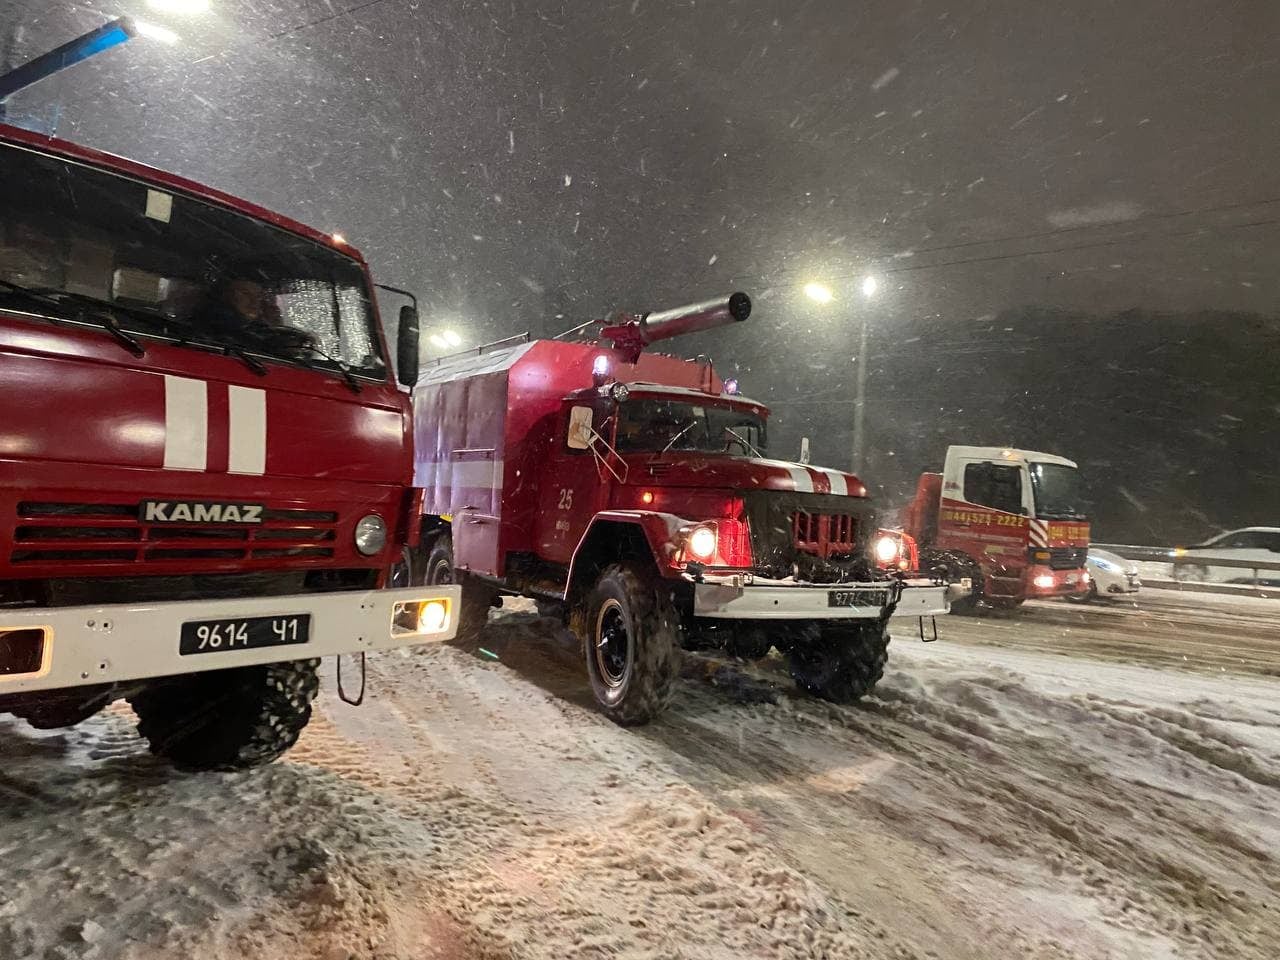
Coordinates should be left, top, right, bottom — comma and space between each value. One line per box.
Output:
787, 620, 890, 704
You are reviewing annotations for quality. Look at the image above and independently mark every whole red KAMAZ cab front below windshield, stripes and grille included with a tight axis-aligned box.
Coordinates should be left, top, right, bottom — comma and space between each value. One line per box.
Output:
0, 316, 411, 589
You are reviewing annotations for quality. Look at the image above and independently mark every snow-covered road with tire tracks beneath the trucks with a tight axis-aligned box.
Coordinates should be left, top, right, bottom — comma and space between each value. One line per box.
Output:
0, 598, 1280, 960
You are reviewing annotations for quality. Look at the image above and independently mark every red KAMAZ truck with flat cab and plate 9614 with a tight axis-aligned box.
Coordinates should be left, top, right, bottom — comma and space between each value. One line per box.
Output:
0, 125, 458, 769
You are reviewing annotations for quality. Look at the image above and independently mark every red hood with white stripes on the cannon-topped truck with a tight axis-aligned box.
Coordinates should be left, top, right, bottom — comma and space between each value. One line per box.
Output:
626, 451, 867, 497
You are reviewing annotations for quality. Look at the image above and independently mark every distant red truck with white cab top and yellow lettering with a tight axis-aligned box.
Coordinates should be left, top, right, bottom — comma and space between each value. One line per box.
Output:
905, 447, 1089, 613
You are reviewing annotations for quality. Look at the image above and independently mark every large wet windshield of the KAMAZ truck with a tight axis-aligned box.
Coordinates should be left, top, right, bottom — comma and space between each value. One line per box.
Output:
0, 145, 385, 379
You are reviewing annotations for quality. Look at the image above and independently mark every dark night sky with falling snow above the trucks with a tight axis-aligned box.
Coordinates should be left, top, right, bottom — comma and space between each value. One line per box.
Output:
0, 0, 1280, 542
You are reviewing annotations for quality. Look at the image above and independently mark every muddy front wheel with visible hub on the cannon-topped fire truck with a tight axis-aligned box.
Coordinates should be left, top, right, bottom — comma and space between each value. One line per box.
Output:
573, 563, 681, 727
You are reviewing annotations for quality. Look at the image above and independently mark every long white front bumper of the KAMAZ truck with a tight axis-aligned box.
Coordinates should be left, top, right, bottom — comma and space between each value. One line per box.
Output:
0, 586, 461, 698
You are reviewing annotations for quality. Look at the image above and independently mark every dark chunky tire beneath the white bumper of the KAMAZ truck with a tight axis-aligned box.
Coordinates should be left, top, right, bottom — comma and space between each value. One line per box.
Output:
129, 659, 320, 771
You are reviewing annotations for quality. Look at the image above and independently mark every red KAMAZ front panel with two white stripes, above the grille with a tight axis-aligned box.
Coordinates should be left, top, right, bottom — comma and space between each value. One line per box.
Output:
0, 315, 410, 493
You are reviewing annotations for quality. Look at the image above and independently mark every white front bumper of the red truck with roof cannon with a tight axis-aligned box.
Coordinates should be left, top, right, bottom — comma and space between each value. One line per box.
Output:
694, 576, 960, 620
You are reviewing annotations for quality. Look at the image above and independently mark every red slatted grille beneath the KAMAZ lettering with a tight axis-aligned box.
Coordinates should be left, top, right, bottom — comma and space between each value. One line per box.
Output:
9, 502, 338, 564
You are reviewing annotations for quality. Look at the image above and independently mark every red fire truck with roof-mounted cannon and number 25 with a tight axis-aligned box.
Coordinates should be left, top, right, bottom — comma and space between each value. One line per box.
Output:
413, 293, 947, 724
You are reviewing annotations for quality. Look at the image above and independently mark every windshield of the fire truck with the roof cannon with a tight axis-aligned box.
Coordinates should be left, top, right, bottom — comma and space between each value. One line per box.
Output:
617, 398, 765, 457
